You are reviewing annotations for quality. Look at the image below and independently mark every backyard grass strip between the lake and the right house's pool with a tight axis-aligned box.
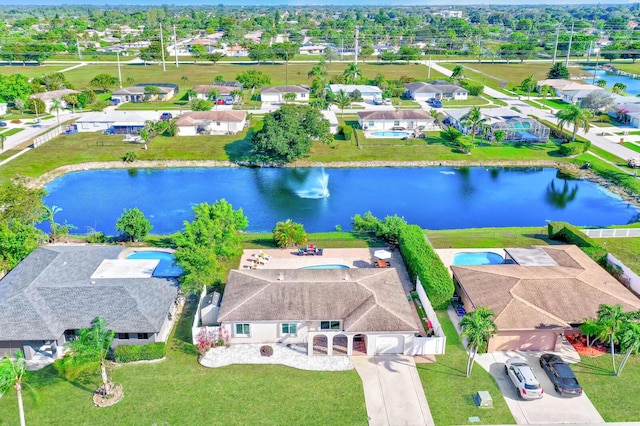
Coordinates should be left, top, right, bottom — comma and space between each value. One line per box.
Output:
425, 226, 557, 249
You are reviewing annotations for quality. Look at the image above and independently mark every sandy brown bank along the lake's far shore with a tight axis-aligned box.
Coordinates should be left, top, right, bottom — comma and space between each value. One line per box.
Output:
29, 160, 640, 207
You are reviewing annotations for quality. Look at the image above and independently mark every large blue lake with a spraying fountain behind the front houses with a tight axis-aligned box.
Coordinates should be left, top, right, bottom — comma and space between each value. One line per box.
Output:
41, 167, 639, 235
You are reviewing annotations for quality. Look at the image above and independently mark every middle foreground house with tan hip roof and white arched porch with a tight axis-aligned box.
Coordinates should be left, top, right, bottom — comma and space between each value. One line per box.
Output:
218, 268, 420, 356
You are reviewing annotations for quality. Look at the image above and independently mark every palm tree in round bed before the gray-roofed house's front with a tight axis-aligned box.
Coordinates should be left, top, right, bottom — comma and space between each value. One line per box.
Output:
65, 317, 115, 395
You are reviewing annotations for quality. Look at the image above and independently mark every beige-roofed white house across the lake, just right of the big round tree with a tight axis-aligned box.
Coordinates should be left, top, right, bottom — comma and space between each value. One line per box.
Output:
358, 109, 436, 130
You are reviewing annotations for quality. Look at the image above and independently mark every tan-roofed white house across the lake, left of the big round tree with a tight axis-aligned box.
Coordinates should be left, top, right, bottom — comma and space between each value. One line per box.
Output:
176, 111, 247, 136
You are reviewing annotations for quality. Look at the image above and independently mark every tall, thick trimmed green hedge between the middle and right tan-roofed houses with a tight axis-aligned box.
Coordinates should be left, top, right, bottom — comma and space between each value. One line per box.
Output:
398, 225, 455, 309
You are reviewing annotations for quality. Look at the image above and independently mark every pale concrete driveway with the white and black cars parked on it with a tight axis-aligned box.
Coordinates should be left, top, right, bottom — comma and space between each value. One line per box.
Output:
479, 351, 604, 424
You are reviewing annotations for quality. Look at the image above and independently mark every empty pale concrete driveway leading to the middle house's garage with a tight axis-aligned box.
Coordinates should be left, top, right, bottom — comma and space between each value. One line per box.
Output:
350, 355, 434, 426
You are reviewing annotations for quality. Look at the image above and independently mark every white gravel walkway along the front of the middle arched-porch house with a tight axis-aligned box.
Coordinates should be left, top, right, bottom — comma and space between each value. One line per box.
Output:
200, 344, 353, 371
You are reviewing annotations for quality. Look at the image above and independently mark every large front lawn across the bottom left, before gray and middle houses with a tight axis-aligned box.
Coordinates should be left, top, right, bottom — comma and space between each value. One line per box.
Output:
0, 303, 367, 426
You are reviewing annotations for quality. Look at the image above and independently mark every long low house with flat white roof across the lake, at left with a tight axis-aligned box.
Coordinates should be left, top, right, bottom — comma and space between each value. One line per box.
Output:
75, 111, 159, 135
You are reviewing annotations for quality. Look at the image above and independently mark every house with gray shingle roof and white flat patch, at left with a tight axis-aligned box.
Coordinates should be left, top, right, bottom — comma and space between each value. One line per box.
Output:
0, 245, 178, 359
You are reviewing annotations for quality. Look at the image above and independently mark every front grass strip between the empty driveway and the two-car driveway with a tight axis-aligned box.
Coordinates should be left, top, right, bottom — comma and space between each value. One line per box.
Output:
416, 311, 515, 426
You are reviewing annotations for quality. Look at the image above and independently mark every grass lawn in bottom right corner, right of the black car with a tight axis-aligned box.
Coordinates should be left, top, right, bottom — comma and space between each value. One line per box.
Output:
573, 350, 640, 422
